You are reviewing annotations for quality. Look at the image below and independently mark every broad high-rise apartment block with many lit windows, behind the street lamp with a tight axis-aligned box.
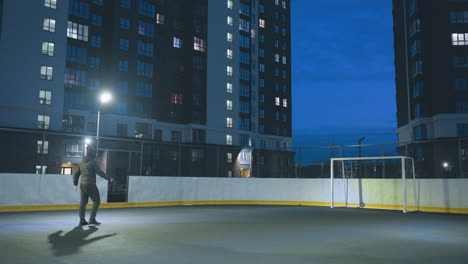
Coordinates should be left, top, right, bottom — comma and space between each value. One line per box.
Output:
0, 0, 292, 179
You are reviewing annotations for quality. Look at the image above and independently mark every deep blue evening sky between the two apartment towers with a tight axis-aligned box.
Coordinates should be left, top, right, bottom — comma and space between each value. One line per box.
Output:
291, 0, 397, 154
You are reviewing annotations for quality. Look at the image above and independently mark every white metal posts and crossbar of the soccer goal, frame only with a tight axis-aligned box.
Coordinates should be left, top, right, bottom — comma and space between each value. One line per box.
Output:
330, 156, 416, 213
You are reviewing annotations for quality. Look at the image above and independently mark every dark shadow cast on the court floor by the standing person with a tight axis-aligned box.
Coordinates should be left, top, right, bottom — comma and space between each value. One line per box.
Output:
49, 226, 117, 256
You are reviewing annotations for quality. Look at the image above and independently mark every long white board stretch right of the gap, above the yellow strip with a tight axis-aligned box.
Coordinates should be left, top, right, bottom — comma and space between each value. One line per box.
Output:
128, 176, 468, 208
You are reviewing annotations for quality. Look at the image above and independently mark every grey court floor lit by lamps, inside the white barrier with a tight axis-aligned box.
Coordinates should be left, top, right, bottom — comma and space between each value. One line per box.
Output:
0, 206, 468, 264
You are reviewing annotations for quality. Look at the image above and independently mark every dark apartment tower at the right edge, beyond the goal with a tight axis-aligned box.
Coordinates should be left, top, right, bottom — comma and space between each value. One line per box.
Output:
393, 0, 468, 177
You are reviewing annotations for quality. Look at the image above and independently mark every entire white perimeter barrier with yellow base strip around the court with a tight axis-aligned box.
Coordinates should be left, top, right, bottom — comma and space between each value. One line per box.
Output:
0, 174, 468, 213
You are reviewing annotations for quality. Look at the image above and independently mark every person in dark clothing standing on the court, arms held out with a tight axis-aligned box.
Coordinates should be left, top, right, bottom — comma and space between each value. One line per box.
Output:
73, 149, 114, 225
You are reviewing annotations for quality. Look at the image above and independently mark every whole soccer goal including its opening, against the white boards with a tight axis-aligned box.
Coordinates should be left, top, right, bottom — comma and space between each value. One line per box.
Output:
330, 156, 418, 213
